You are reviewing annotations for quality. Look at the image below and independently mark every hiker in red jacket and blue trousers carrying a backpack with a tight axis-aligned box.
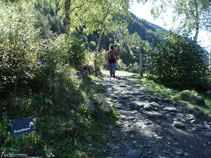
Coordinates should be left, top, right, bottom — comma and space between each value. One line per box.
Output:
107, 44, 118, 77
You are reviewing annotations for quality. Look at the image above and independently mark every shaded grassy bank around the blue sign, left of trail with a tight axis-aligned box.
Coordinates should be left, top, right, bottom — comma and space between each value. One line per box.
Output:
0, 68, 118, 158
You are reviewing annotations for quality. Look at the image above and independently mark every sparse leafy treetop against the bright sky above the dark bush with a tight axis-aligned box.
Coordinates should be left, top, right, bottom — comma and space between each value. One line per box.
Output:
152, 0, 211, 42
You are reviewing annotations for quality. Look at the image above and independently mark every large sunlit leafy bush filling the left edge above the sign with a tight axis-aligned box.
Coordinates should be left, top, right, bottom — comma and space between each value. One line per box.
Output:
0, 3, 61, 104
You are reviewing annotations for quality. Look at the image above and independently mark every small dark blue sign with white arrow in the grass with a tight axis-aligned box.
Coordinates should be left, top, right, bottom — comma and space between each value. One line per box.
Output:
11, 118, 34, 136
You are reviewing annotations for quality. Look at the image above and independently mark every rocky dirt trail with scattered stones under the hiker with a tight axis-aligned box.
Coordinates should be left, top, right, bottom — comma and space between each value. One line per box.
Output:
101, 74, 211, 158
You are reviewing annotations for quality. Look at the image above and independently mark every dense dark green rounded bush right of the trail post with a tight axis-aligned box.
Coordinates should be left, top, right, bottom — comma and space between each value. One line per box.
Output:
148, 32, 208, 89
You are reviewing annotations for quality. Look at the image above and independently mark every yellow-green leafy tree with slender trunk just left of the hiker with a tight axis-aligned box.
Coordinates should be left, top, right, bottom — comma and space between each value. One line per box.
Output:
61, 0, 129, 73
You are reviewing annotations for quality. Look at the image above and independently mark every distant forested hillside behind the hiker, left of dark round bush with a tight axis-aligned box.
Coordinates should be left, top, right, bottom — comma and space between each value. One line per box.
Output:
84, 14, 166, 71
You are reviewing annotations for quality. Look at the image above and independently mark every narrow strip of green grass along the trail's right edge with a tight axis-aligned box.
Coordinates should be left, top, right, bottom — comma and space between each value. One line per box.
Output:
135, 75, 211, 115
